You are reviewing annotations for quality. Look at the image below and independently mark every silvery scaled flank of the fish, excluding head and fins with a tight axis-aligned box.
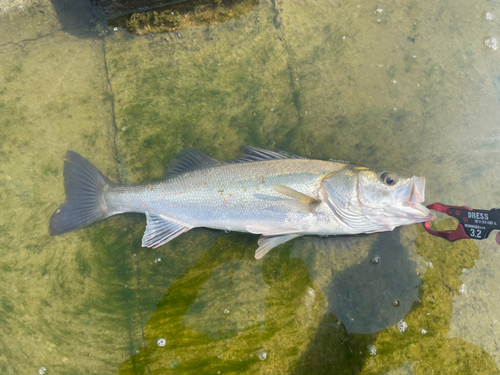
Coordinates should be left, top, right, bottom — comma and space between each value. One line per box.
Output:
105, 159, 346, 231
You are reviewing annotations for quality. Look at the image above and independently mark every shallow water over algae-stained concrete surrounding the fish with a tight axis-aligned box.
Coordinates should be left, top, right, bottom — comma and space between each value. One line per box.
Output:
0, 0, 500, 374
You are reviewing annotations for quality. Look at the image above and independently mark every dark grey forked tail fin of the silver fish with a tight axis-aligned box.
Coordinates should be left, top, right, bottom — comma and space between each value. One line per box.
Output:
50, 151, 116, 236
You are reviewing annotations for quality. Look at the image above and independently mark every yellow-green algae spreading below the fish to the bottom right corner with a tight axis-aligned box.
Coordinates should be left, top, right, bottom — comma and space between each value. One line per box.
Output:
115, 220, 498, 374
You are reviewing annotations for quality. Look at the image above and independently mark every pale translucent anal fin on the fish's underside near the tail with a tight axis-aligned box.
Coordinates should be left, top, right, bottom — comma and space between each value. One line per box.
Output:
142, 211, 191, 249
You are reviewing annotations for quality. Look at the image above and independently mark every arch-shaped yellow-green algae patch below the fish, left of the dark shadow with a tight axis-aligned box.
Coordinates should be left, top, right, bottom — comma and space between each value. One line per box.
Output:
119, 235, 322, 374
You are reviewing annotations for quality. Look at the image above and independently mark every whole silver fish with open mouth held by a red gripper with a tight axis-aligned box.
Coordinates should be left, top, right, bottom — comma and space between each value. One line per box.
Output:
49, 146, 435, 259
